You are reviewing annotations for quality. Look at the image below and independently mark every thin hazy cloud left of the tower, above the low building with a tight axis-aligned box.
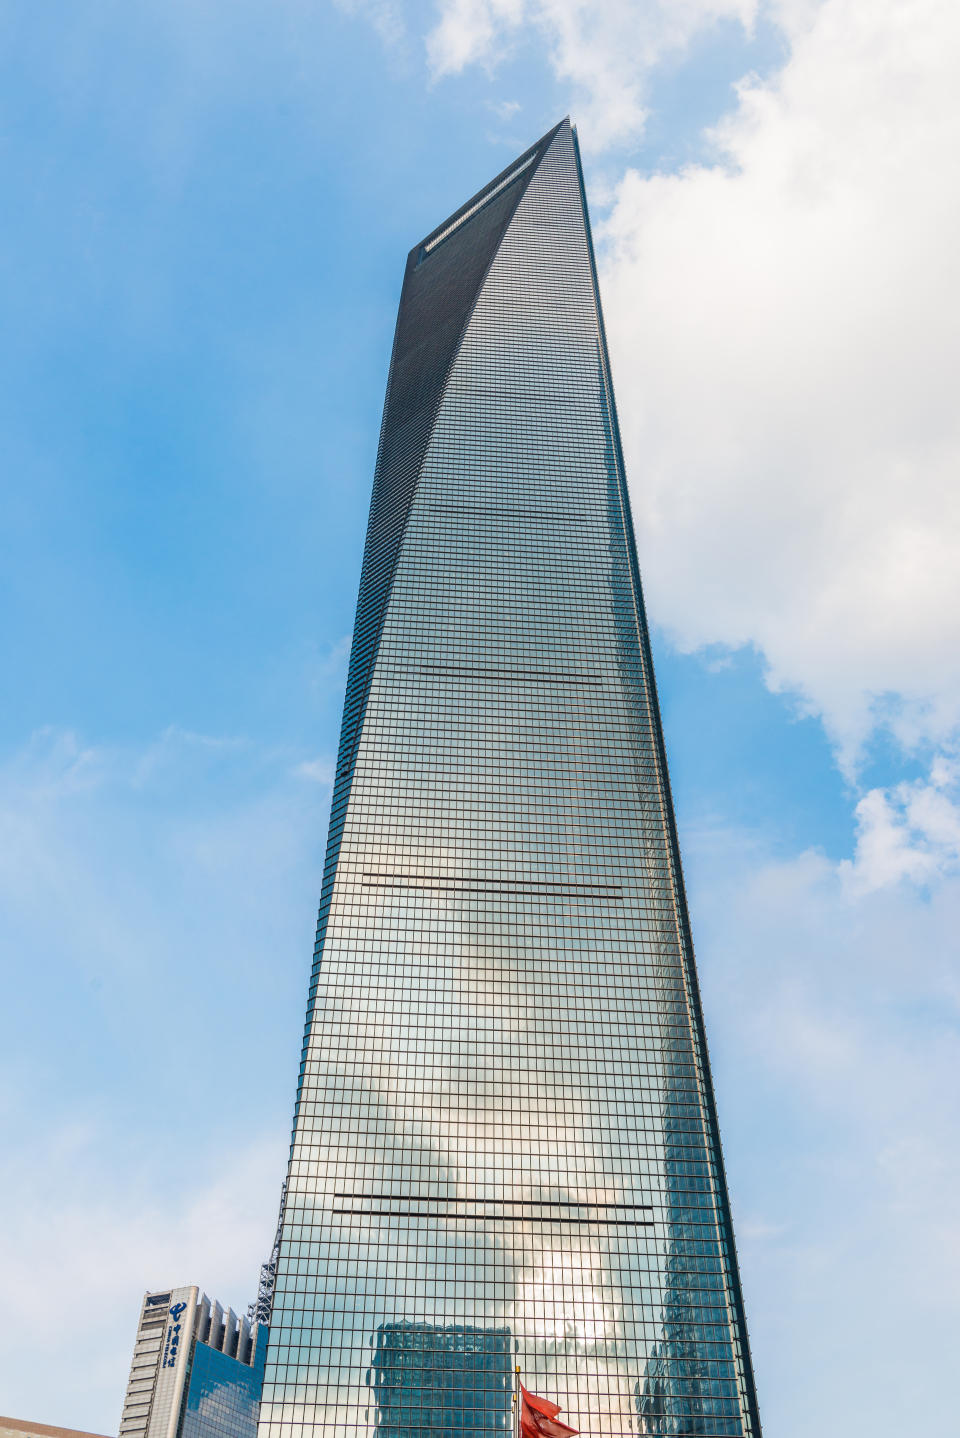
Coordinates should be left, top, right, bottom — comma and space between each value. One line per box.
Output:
0, 728, 328, 1432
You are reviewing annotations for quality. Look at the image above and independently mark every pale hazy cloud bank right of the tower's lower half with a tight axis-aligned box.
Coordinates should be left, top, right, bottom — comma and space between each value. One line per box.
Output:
687, 830, 960, 1438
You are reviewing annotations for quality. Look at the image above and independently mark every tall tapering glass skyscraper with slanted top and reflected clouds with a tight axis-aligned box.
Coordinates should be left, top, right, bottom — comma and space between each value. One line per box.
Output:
260, 121, 760, 1438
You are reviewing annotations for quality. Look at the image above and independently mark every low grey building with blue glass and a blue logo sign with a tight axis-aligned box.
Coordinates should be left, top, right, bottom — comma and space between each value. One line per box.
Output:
119, 1286, 267, 1438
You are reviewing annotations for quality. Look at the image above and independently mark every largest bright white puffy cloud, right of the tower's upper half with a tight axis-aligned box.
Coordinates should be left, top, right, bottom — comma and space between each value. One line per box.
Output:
602, 0, 960, 765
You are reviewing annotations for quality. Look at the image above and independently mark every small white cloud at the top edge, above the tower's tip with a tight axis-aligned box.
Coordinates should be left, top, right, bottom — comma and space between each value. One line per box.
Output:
427, 0, 757, 150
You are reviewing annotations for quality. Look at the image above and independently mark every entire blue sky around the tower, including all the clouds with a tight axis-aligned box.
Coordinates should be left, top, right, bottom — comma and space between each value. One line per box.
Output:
0, 0, 960, 1438
